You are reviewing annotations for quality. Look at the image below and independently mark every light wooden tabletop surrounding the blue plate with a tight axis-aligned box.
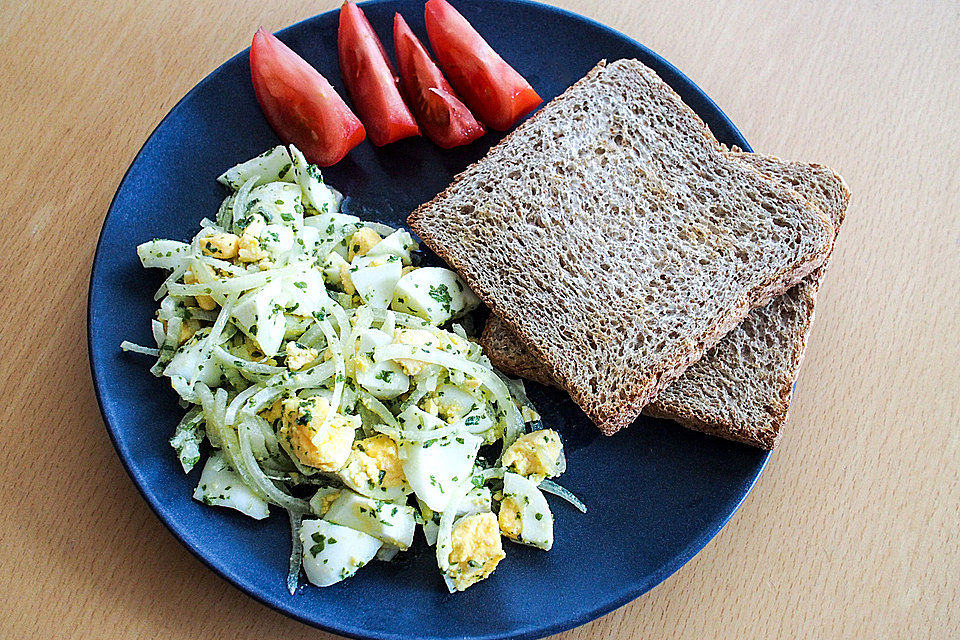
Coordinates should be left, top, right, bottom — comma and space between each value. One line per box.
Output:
0, 0, 960, 640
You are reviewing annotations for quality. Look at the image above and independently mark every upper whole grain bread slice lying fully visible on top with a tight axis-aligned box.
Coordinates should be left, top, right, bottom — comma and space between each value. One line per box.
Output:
408, 60, 833, 434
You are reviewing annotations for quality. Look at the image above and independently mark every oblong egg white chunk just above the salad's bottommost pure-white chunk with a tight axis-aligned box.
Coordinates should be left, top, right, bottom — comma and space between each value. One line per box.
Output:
324, 491, 417, 549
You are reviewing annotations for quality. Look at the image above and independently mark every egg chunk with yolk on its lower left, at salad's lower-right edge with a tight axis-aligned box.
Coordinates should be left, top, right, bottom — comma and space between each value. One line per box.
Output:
498, 472, 553, 551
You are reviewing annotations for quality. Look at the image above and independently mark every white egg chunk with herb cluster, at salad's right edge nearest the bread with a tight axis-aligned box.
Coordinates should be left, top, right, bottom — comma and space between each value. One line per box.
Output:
391, 267, 480, 325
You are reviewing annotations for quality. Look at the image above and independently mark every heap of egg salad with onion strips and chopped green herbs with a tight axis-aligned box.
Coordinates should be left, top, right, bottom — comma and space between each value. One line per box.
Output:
121, 146, 585, 593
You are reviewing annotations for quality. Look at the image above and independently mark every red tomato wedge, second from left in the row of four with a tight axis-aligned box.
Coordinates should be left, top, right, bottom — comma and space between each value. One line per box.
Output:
337, 2, 420, 147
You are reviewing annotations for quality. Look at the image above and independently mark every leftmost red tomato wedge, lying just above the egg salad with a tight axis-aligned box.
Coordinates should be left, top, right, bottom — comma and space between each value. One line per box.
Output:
250, 27, 366, 167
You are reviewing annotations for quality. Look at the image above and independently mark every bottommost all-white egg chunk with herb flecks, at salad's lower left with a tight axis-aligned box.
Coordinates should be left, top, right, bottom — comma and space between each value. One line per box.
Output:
300, 520, 383, 587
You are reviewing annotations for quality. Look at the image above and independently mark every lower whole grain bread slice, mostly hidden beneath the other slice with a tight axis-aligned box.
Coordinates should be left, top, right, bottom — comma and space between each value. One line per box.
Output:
480, 153, 850, 449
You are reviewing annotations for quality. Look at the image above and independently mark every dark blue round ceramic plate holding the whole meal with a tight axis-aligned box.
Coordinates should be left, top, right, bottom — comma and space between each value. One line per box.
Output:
89, 0, 767, 639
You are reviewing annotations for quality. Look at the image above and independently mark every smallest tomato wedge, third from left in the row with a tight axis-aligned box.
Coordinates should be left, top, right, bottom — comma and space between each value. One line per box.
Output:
393, 13, 485, 149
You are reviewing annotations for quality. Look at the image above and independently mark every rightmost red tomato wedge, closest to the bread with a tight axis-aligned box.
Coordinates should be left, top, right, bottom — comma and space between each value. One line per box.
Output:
424, 0, 543, 131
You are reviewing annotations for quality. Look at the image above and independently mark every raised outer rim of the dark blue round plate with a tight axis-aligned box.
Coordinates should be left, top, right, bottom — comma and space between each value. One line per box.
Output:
86, 0, 772, 640
